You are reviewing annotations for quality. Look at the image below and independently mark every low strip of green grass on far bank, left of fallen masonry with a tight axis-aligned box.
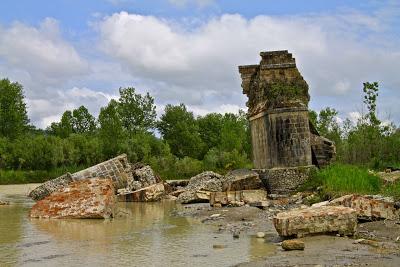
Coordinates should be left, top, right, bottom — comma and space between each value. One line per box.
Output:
0, 166, 85, 184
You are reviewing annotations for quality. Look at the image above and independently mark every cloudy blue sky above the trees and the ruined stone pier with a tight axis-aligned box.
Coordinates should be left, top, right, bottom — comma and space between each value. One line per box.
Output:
0, 0, 400, 128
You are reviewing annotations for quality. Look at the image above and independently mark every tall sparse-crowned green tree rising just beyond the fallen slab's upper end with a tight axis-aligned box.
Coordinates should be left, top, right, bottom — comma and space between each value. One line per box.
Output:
118, 87, 157, 133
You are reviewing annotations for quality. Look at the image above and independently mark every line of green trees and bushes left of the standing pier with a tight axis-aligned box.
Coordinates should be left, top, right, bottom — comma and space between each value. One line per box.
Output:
0, 79, 251, 178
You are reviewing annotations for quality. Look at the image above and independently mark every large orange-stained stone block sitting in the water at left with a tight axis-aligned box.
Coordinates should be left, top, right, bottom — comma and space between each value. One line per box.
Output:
30, 178, 115, 219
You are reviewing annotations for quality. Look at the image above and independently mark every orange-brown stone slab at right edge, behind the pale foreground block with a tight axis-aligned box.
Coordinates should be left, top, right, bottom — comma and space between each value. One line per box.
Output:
328, 195, 400, 220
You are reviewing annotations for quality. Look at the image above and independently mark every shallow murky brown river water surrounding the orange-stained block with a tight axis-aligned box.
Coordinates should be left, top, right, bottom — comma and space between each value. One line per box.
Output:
0, 185, 271, 267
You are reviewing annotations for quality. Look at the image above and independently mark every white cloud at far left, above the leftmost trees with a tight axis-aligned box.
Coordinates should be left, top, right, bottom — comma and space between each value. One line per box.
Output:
0, 18, 88, 85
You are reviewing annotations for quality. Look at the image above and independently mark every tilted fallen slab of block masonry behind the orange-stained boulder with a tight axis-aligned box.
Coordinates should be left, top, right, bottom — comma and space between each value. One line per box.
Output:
29, 154, 133, 201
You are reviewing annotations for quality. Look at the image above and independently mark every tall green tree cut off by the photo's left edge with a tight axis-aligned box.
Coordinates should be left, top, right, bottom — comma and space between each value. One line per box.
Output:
0, 79, 29, 139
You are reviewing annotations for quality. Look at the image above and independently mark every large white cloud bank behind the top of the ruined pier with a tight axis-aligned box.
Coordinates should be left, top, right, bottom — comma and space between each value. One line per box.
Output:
99, 11, 400, 121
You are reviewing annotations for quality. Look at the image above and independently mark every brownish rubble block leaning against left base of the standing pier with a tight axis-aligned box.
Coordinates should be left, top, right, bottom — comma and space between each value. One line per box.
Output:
222, 169, 264, 191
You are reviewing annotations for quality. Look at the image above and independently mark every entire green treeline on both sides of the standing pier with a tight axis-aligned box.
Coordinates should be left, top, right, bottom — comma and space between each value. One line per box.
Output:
0, 79, 400, 183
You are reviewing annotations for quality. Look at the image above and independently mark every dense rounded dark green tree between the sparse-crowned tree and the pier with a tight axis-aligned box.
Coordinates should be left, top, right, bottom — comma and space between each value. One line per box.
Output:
157, 104, 204, 159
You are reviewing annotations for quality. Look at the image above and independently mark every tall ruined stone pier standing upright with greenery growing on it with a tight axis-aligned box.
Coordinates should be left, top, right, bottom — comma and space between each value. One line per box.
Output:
239, 50, 334, 192
